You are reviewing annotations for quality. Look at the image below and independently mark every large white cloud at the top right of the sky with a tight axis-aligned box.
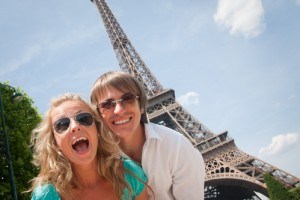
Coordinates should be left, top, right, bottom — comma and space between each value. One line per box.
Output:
214, 0, 265, 38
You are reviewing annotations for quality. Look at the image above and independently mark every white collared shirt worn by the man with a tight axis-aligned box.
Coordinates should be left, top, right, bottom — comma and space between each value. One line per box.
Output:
122, 123, 205, 200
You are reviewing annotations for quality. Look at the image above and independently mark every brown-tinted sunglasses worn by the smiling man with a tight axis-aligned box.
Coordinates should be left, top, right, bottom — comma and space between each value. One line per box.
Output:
97, 93, 139, 112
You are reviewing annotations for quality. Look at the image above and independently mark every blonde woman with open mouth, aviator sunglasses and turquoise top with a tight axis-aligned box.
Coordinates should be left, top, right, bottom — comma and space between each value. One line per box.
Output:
30, 94, 148, 200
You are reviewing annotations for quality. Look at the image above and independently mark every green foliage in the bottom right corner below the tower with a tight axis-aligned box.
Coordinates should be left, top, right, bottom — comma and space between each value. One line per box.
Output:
264, 173, 300, 200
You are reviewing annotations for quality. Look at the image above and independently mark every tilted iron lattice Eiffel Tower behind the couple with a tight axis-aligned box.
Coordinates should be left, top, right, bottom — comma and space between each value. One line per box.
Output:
91, 0, 300, 199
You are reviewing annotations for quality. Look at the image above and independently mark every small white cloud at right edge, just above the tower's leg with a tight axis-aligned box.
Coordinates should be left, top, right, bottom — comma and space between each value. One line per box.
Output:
259, 133, 300, 156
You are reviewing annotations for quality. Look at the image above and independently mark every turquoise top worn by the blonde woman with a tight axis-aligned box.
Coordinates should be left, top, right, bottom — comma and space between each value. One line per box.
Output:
31, 158, 147, 200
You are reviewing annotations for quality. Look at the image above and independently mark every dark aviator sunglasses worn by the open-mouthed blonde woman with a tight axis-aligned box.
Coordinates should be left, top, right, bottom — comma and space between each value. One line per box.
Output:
53, 113, 94, 134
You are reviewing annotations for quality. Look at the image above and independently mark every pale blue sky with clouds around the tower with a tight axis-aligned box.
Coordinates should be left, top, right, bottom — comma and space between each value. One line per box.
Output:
0, 0, 300, 180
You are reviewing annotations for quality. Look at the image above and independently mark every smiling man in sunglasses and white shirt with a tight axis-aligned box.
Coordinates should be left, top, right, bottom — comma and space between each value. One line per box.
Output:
91, 71, 205, 200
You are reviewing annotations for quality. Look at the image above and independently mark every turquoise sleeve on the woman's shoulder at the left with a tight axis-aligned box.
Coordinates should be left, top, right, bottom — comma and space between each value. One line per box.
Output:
31, 183, 60, 200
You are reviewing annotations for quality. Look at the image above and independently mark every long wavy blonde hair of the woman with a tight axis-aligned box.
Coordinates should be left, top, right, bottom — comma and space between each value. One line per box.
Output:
29, 94, 131, 199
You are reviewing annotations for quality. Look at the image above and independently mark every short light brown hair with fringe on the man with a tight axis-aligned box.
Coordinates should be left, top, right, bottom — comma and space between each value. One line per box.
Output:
90, 71, 148, 123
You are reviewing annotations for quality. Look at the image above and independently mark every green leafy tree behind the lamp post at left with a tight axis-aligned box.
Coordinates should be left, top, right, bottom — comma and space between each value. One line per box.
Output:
0, 83, 42, 200
